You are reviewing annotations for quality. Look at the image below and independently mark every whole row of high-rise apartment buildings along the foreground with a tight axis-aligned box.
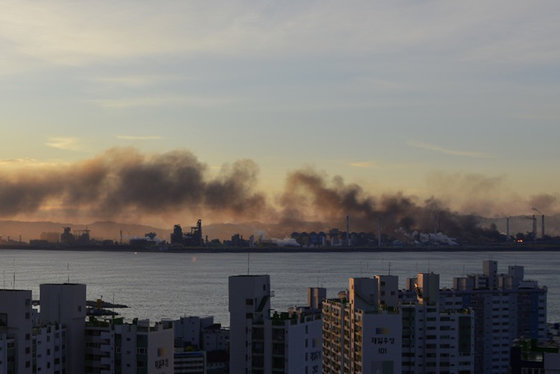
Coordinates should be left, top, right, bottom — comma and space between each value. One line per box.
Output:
0, 260, 560, 374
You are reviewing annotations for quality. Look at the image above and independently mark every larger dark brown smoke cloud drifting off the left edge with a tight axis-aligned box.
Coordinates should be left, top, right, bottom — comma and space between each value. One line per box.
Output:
0, 148, 265, 218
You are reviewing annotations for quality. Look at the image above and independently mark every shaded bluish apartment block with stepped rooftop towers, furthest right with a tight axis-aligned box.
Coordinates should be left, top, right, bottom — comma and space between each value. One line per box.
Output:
446, 261, 547, 374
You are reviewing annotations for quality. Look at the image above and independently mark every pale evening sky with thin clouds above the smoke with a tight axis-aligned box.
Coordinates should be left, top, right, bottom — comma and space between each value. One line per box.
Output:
0, 0, 560, 225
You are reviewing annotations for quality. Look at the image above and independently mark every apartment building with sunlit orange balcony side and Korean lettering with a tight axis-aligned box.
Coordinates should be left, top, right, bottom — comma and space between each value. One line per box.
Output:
322, 275, 402, 374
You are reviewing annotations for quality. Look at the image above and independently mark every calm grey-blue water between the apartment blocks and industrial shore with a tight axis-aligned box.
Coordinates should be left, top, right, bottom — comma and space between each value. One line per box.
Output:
0, 250, 560, 326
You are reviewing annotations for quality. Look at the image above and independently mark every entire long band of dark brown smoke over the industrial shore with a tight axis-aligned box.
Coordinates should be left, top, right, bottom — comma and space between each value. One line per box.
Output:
0, 148, 558, 237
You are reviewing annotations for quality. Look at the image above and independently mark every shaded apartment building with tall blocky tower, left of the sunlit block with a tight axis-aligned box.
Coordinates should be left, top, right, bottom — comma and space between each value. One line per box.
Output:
229, 275, 326, 374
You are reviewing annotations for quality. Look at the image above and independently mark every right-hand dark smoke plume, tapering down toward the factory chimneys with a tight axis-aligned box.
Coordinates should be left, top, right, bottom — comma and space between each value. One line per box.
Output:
280, 169, 504, 238
